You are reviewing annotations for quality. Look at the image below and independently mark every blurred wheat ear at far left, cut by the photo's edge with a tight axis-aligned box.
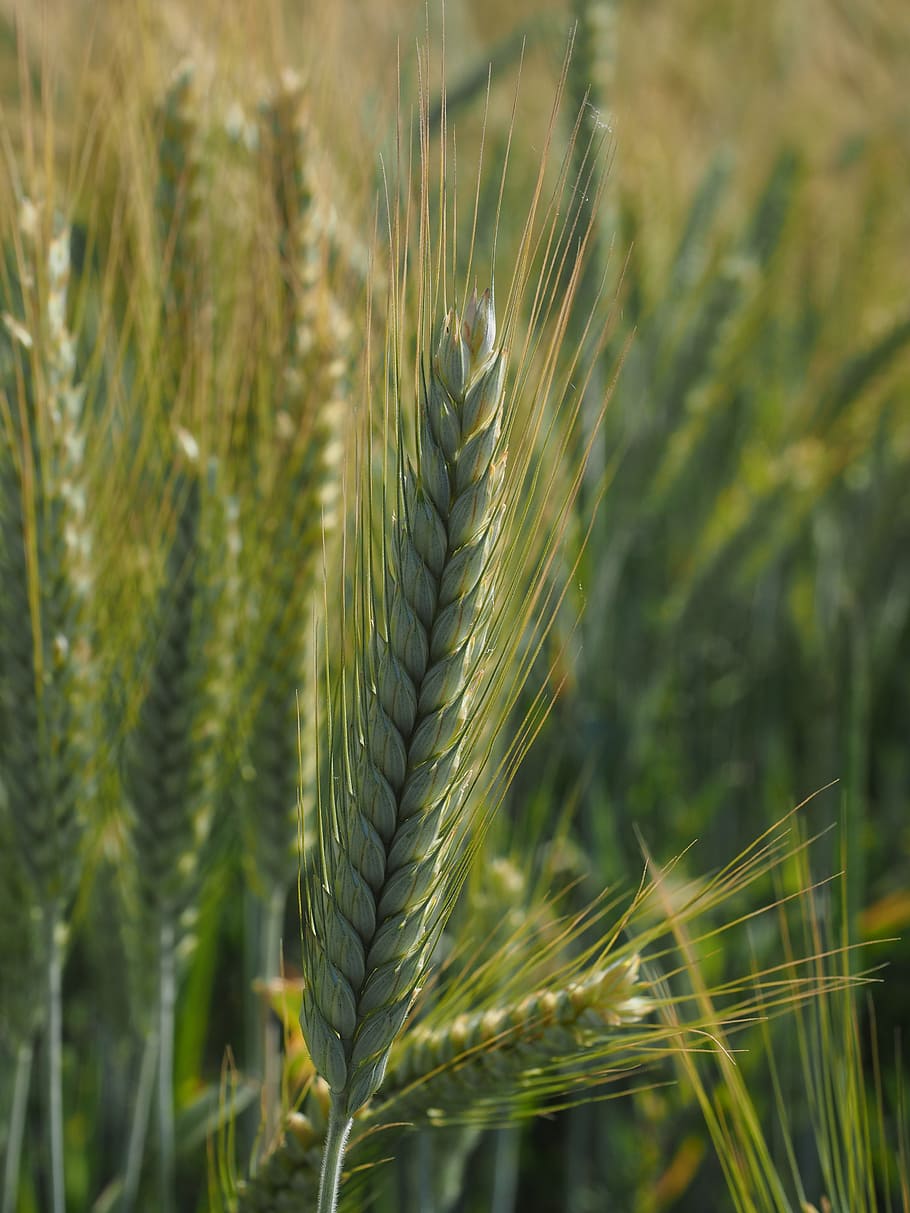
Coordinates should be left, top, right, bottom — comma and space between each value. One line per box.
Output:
0, 201, 95, 915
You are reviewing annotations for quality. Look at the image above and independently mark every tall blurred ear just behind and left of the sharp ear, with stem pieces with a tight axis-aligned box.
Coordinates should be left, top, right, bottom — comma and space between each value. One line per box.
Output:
231, 63, 351, 1150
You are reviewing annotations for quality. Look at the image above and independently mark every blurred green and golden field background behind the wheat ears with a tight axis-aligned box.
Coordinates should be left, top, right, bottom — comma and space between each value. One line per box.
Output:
0, 0, 910, 1213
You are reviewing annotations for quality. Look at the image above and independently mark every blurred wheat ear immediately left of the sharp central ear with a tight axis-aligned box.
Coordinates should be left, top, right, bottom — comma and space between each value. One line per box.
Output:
248, 74, 349, 897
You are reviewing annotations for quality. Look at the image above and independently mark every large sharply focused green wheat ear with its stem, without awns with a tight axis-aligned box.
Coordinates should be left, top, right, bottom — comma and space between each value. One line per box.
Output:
301, 291, 505, 1213
